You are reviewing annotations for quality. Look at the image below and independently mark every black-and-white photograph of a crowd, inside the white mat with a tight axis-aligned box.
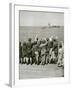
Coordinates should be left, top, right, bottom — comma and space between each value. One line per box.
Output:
19, 10, 64, 80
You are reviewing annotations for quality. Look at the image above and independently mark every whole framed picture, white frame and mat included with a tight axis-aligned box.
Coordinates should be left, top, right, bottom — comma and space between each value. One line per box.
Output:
9, 4, 69, 86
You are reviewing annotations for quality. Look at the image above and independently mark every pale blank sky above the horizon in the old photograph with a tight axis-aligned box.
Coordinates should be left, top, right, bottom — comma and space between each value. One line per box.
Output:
19, 10, 64, 26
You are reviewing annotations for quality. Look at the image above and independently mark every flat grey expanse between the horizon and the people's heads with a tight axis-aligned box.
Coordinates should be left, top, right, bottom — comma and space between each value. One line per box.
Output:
19, 26, 64, 42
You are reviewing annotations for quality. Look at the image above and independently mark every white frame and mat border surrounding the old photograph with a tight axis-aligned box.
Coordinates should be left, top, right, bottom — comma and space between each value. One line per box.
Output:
11, 4, 70, 86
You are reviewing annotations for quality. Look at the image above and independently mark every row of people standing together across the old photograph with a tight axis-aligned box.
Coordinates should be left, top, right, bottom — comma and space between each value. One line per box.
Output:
19, 37, 64, 66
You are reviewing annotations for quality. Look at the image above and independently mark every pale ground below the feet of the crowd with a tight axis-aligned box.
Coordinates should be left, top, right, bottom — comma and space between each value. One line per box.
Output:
19, 64, 64, 79
